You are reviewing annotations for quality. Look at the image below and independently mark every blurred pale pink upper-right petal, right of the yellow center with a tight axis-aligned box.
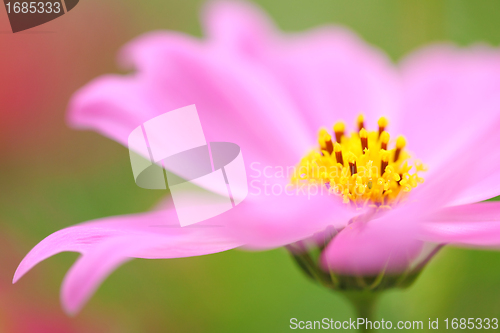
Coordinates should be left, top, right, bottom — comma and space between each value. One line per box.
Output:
399, 45, 500, 164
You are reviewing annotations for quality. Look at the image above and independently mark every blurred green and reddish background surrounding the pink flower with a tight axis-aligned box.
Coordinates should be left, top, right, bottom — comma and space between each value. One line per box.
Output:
0, 0, 500, 333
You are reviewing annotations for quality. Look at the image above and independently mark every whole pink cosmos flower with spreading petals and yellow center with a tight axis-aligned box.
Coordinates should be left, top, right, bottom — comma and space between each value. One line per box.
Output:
14, 2, 500, 312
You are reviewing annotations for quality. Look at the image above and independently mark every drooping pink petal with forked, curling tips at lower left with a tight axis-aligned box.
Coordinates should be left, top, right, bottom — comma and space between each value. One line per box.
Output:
13, 210, 241, 313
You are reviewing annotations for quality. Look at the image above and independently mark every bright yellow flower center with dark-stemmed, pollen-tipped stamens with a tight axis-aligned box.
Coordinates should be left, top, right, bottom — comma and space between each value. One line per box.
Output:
292, 115, 426, 208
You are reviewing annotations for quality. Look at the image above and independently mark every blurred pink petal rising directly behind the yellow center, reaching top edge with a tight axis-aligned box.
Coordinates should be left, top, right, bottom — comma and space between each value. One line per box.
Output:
204, 1, 399, 131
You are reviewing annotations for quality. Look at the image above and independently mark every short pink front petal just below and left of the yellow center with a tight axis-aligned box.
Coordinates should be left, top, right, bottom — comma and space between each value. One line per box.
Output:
220, 187, 362, 249
